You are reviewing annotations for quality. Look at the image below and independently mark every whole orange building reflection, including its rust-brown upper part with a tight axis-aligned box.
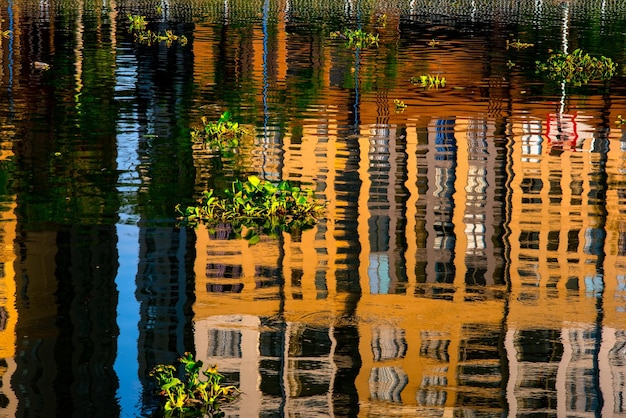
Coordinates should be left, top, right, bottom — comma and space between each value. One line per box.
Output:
189, 2, 626, 416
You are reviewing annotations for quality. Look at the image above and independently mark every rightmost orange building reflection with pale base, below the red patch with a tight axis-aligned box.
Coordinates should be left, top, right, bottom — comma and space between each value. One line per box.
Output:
506, 113, 625, 416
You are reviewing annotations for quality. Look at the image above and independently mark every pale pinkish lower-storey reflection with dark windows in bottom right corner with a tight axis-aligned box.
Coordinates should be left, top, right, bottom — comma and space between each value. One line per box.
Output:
505, 326, 626, 416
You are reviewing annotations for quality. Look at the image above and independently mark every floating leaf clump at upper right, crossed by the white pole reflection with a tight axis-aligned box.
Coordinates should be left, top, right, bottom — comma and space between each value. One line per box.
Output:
536, 49, 617, 86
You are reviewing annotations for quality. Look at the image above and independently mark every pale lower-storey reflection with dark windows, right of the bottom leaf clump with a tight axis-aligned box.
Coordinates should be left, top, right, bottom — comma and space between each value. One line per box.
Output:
195, 315, 346, 416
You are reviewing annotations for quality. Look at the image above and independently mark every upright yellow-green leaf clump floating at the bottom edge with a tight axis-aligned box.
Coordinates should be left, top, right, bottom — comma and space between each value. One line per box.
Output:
150, 352, 239, 417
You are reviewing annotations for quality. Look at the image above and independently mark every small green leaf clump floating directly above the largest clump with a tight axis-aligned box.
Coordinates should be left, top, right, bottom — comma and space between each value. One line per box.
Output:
191, 111, 248, 151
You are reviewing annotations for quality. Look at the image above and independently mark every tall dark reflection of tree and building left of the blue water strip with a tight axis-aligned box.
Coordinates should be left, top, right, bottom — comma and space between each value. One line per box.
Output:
11, 1, 118, 416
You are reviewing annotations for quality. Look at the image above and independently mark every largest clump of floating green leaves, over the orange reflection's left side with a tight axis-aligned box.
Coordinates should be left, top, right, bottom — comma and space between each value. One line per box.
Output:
176, 176, 325, 245
